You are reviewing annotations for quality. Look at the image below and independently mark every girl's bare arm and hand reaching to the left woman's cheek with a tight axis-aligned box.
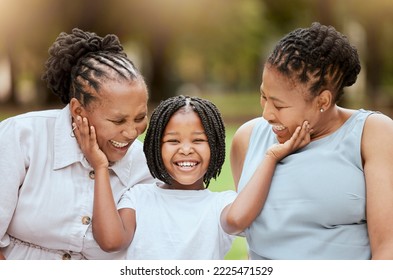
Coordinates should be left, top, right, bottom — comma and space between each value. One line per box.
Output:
73, 117, 135, 252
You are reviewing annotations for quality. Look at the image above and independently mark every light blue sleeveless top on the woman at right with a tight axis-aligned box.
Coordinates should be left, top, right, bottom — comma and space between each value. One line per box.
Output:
239, 109, 372, 260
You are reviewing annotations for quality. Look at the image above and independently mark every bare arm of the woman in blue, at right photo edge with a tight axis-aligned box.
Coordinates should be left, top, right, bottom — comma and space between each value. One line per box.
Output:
361, 114, 393, 259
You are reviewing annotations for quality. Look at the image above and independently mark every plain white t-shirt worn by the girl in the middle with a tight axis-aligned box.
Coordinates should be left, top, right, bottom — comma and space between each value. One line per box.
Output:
118, 183, 236, 260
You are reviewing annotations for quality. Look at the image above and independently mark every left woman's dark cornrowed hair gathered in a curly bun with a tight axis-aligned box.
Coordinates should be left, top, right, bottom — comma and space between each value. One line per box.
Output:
42, 28, 140, 105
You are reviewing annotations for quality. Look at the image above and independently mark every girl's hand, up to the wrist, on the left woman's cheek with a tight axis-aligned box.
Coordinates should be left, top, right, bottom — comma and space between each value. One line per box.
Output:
72, 116, 109, 169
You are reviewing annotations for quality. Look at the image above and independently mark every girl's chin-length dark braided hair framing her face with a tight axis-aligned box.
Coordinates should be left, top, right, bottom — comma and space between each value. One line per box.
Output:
143, 95, 225, 188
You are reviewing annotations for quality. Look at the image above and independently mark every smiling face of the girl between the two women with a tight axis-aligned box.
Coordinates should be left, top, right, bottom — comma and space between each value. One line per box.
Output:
161, 107, 210, 190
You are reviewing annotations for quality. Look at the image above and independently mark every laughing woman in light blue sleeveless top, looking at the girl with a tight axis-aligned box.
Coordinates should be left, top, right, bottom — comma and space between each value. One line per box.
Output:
231, 23, 393, 259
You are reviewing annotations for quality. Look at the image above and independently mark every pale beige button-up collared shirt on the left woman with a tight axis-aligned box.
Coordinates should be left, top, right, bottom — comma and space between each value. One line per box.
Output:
0, 106, 155, 259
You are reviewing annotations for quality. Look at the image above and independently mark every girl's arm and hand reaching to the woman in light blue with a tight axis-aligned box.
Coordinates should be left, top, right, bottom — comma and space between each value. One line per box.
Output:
221, 122, 310, 234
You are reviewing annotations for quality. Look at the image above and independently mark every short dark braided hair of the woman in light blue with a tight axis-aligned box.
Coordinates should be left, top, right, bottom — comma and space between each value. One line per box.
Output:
267, 22, 361, 102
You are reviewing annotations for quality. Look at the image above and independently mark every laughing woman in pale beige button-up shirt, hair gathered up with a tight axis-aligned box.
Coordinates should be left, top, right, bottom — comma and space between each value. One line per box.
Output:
0, 28, 155, 259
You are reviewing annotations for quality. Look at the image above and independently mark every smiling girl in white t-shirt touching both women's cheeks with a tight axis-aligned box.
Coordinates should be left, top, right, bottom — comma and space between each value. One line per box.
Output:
74, 96, 310, 259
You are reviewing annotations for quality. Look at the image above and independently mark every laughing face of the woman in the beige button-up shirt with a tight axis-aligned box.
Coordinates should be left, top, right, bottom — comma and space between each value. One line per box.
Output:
71, 77, 148, 162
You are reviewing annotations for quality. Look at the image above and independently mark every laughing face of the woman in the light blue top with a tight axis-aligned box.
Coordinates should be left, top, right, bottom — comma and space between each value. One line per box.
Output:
261, 67, 319, 143
